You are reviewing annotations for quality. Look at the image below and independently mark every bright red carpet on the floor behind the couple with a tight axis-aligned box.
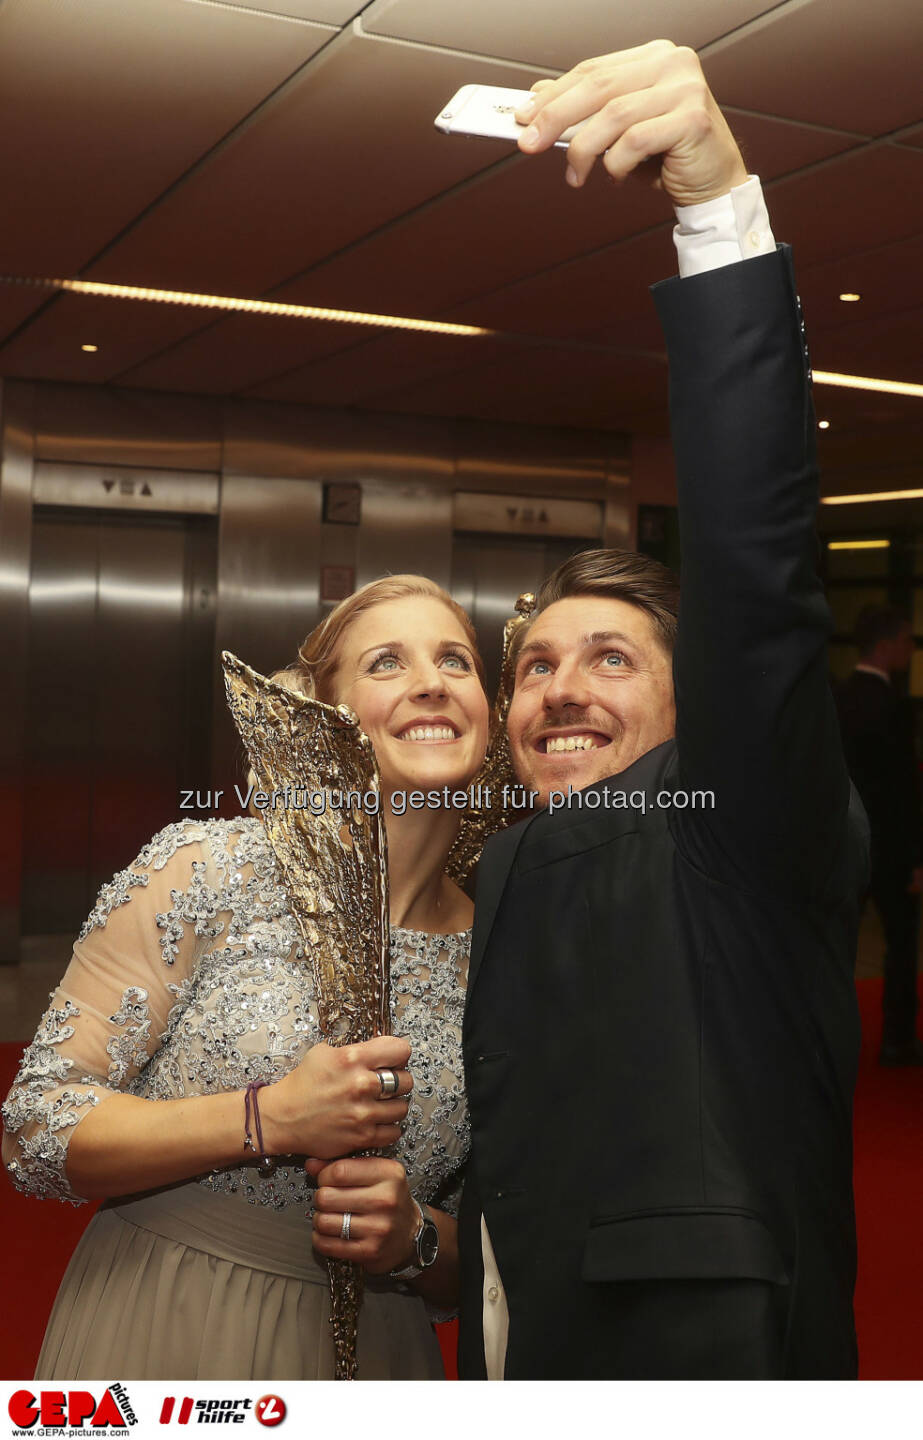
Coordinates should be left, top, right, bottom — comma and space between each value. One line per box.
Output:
0, 979, 923, 1380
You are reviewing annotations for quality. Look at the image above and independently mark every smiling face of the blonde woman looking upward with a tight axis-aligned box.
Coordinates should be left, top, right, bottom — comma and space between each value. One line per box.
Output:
334, 595, 488, 793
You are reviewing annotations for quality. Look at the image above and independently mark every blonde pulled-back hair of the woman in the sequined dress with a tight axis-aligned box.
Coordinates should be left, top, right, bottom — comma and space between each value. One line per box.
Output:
271, 575, 485, 704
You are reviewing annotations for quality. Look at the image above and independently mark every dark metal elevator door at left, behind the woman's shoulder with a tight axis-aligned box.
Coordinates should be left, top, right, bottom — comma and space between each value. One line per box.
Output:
23, 510, 216, 936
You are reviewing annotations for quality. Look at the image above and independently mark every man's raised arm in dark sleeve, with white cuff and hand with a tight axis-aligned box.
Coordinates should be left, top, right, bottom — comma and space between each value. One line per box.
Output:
517, 40, 848, 899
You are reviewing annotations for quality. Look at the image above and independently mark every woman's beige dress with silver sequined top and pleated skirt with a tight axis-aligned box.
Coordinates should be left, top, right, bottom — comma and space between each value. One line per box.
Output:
3, 818, 469, 1380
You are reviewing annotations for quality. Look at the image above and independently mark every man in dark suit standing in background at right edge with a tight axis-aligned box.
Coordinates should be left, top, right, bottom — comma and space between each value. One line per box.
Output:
837, 605, 923, 1066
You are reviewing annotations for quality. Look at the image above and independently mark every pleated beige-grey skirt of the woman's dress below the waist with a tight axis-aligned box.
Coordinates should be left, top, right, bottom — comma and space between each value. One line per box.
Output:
36, 1182, 445, 1380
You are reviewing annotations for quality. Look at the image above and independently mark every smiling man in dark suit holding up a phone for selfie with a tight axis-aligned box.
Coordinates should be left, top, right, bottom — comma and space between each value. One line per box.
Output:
459, 42, 867, 1380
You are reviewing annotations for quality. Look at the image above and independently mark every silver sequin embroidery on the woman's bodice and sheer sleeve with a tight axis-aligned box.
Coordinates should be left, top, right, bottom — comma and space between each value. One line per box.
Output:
3, 818, 469, 1211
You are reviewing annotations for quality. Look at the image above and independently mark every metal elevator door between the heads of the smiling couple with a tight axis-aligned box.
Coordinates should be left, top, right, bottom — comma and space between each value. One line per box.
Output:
452, 534, 590, 698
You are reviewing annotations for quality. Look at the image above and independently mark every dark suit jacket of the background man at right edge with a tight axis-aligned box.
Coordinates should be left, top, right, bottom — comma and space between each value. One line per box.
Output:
837, 670, 923, 878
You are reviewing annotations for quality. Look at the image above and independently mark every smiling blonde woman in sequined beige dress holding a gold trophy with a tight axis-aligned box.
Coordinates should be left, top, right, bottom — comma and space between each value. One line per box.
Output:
3, 576, 488, 1380
